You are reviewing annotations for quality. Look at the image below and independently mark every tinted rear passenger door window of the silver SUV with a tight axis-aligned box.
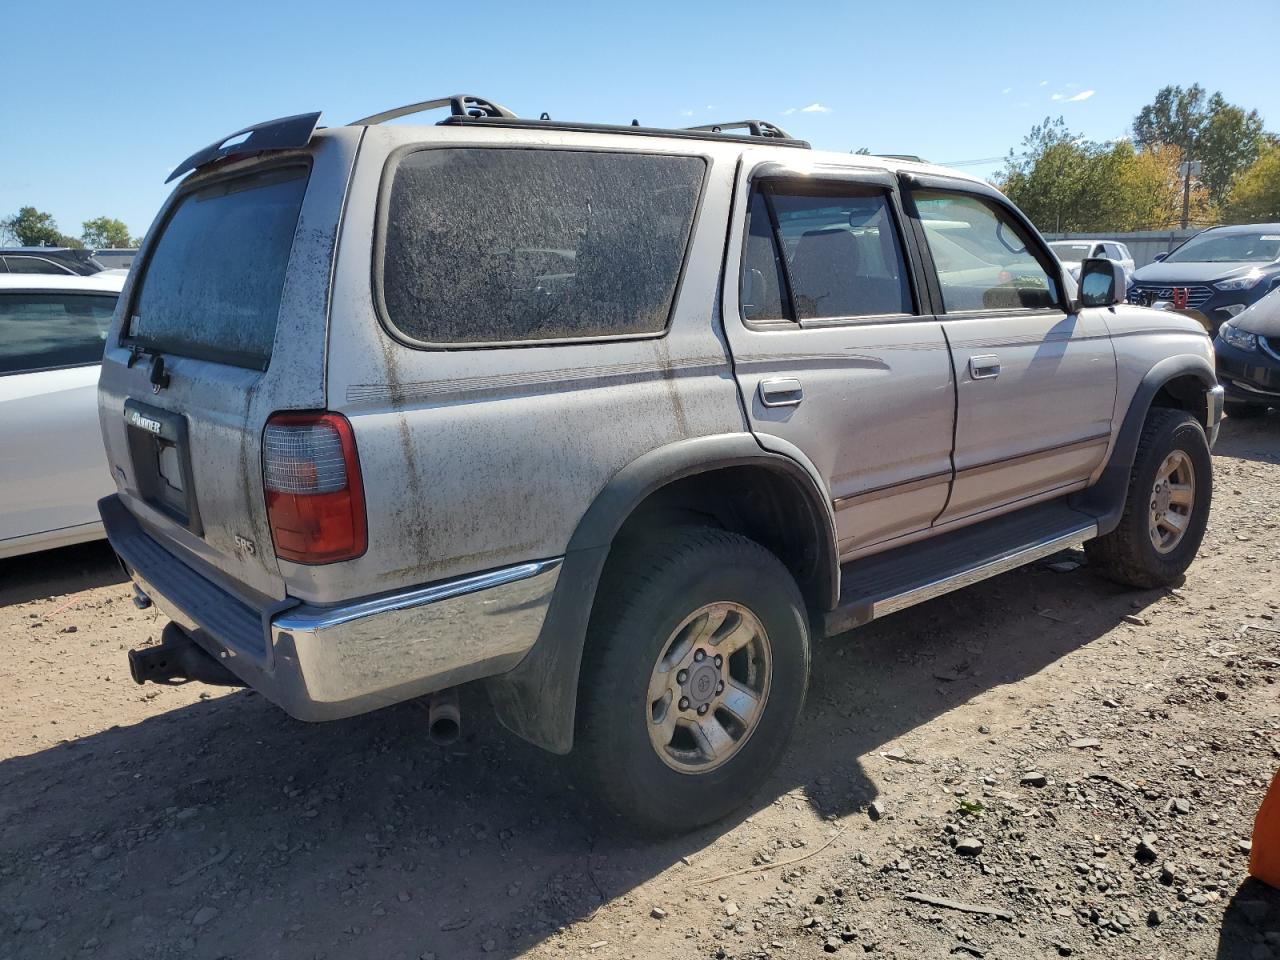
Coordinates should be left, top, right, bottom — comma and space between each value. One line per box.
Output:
741, 183, 915, 320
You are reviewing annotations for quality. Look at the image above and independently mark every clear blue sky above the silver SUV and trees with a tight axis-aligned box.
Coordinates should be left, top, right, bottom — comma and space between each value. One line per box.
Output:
0, 0, 1280, 241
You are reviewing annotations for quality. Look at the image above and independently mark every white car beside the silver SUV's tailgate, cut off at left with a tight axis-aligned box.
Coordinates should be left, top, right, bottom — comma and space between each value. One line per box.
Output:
0, 274, 125, 557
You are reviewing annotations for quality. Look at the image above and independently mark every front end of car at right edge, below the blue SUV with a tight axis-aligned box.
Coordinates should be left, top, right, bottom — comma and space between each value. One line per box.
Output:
1213, 289, 1280, 417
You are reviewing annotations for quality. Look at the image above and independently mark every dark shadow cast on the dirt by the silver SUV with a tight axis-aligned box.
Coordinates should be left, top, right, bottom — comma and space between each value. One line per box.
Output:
0, 567, 1158, 960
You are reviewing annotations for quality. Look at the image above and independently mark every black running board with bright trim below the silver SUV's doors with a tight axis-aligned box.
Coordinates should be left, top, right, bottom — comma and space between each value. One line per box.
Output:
826, 500, 1098, 636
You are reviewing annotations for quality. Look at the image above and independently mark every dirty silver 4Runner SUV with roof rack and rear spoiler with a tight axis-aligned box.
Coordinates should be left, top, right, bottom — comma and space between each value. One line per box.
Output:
100, 96, 1222, 829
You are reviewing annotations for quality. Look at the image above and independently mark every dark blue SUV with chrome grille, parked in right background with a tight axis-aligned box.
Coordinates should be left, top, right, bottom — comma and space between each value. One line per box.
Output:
1129, 223, 1280, 333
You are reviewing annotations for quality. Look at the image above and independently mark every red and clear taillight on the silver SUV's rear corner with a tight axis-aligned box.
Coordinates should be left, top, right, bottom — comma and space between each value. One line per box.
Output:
262, 413, 369, 563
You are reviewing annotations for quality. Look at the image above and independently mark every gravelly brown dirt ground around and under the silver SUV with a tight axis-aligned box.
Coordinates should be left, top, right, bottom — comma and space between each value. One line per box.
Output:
0, 415, 1280, 960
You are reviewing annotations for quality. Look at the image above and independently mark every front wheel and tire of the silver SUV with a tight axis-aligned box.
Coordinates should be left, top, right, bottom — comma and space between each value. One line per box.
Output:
1084, 407, 1213, 588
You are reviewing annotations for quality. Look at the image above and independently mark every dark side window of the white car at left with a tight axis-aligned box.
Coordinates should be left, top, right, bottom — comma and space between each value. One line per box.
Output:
0, 293, 115, 374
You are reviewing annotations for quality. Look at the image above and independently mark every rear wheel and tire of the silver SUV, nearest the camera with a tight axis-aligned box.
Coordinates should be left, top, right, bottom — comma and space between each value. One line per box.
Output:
576, 527, 810, 835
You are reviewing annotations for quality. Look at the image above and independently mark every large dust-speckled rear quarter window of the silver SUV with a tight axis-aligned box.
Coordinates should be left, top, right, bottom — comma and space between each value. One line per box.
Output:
379, 148, 705, 344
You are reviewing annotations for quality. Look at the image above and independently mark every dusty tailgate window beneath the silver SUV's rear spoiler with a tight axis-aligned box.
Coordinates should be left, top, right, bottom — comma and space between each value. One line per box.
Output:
125, 166, 307, 370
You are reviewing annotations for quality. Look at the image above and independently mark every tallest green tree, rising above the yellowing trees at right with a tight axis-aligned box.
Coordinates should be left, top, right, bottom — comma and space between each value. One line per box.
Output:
1133, 83, 1266, 205
